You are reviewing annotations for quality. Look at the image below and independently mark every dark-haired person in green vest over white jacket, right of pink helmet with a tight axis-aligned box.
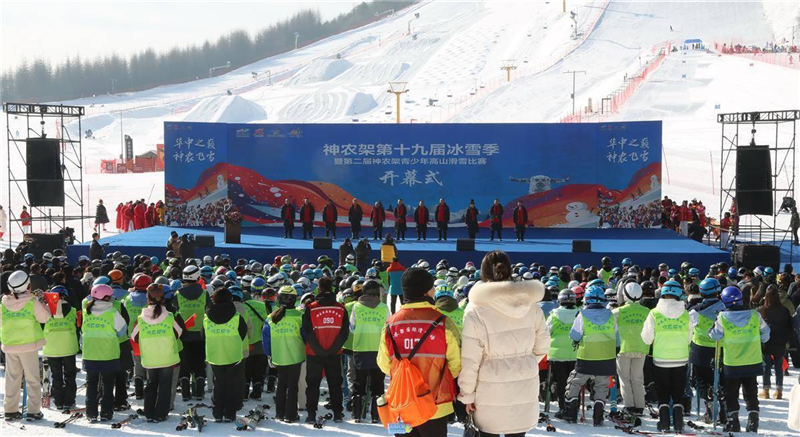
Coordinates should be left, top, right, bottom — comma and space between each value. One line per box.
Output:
131, 282, 185, 422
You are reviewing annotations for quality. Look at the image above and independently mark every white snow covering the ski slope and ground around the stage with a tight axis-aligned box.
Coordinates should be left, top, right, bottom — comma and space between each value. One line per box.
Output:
0, 1, 800, 430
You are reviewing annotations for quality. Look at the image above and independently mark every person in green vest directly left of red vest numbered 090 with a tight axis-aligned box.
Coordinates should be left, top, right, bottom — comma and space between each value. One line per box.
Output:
261, 285, 306, 422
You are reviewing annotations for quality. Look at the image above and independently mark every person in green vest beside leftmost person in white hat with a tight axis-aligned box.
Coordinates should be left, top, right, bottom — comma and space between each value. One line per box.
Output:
42, 285, 79, 410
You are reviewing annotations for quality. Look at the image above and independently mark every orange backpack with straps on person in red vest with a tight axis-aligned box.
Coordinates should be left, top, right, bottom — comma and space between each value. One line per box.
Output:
378, 316, 445, 428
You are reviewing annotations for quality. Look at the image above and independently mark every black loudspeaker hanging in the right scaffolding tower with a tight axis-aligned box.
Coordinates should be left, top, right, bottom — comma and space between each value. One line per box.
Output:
736, 146, 774, 215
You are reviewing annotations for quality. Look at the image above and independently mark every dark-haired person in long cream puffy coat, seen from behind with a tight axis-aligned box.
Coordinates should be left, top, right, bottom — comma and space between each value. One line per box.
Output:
458, 251, 550, 437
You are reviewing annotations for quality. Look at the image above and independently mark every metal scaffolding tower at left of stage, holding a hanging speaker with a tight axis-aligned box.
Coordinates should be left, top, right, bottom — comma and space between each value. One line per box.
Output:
3, 103, 89, 247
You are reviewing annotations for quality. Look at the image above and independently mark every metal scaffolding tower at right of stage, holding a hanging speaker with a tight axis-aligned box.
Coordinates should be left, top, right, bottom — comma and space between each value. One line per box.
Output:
717, 110, 800, 260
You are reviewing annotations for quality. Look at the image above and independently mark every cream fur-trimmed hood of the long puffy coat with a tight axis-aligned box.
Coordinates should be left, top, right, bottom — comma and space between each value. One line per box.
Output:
469, 280, 544, 318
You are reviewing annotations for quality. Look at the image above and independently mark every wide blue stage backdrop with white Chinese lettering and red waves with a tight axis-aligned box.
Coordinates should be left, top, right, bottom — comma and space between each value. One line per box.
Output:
164, 121, 661, 228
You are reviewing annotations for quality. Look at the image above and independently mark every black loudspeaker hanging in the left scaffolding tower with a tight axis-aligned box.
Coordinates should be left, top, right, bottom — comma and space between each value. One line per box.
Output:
25, 138, 64, 206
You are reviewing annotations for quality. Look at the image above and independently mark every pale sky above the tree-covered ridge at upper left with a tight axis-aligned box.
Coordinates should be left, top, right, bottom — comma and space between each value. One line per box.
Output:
0, 0, 360, 71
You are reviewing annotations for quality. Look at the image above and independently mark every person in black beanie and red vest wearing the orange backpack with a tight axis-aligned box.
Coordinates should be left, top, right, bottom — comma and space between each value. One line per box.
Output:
377, 267, 461, 437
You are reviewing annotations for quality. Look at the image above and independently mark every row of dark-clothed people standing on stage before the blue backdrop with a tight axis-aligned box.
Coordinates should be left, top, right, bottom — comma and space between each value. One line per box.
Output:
281, 198, 533, 241
